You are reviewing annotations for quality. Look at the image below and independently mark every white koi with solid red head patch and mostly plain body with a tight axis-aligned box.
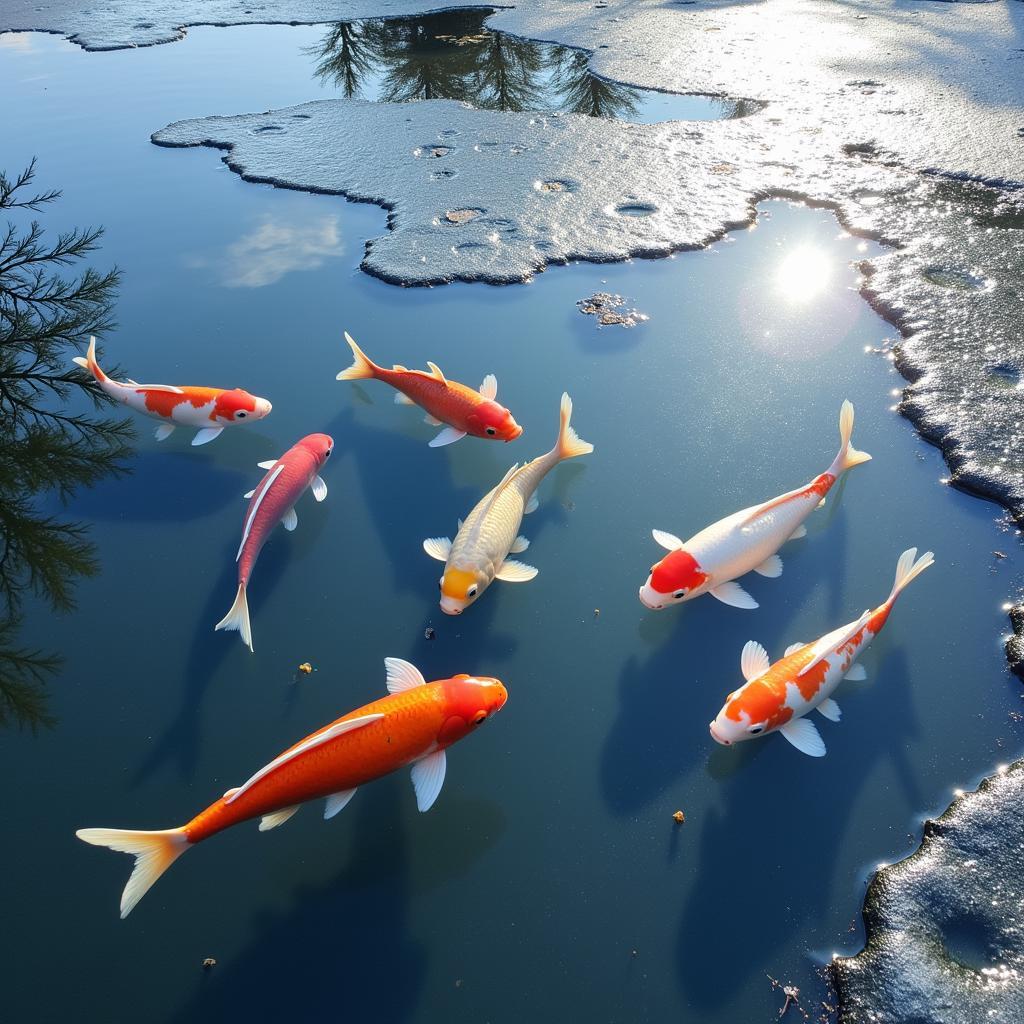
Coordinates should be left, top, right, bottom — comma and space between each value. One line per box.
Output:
640, 401, 871, 611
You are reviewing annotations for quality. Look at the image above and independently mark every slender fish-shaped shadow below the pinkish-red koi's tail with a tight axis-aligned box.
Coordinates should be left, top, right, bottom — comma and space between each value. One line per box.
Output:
132, 544, 290, 786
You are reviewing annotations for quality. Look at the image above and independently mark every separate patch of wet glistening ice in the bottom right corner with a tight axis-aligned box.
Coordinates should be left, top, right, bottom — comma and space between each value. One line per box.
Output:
833, 762, 1024, 1024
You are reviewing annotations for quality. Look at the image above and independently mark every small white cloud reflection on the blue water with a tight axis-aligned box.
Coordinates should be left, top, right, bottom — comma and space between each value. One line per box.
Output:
189, 215, 345, 288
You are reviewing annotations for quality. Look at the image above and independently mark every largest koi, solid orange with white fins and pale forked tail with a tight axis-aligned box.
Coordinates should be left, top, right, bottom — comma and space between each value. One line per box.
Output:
75, 657, 508, 920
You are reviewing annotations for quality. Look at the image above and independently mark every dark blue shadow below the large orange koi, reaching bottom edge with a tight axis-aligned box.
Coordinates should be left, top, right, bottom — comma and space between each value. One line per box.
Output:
169, 778, 428, 1024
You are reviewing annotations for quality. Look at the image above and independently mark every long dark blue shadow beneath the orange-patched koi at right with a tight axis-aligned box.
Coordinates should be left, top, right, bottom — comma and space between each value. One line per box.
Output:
676, 647, 923, 1013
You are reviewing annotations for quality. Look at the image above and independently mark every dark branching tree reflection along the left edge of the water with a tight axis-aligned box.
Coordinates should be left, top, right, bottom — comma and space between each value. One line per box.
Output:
0, 162, 131, 729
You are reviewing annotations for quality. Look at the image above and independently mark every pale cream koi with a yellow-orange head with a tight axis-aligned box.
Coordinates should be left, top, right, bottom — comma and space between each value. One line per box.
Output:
423, 394, 594, 615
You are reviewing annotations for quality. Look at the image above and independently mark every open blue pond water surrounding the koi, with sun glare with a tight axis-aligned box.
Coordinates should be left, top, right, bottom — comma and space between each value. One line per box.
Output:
0, 22, 1024, 1024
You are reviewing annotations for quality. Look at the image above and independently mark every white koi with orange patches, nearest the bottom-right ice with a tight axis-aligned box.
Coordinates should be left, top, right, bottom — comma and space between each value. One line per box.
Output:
711, 548, 935, 758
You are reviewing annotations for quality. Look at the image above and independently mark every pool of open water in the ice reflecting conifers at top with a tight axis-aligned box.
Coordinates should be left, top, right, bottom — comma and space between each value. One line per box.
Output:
310, 7, 766, 124
